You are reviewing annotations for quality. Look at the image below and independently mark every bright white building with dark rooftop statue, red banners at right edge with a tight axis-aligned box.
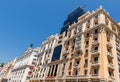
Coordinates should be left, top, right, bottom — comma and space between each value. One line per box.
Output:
8, 47, 39, 82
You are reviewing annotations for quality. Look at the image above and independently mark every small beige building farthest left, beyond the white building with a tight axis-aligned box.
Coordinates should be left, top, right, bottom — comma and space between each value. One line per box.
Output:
0, 58, 16, 82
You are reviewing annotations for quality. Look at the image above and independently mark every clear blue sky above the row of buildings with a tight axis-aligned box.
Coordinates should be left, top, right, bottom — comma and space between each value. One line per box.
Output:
0, 0, 120, 62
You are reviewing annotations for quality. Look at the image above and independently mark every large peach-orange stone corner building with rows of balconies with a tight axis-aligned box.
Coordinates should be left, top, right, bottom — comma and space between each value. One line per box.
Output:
30, 6, 120, 82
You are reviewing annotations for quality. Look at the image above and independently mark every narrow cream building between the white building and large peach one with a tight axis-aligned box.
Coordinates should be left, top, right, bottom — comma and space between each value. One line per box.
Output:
30, 34, 59, 81
